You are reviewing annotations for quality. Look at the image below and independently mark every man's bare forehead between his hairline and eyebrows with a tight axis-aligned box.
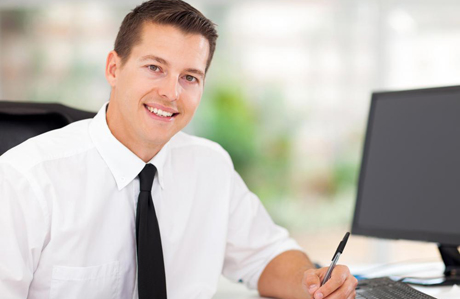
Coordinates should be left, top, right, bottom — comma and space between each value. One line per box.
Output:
132, 22, 209, 72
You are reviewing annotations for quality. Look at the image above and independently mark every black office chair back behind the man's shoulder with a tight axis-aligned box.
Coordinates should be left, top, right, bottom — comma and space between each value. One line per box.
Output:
0, 101, 96, 155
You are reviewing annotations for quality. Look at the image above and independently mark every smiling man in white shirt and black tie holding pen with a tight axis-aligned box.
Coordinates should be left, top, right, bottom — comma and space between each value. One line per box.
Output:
0, 0, 356, 299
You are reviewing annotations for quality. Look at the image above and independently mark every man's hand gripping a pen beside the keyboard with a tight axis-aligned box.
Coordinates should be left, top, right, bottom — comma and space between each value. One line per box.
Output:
302, 265, 358, 299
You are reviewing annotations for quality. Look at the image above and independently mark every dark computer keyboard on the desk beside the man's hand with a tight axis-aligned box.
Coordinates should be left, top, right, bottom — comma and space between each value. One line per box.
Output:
356, 277, 436, 299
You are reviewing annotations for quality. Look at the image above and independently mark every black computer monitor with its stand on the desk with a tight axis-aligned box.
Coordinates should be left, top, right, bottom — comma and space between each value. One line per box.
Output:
352, 86, 460, 284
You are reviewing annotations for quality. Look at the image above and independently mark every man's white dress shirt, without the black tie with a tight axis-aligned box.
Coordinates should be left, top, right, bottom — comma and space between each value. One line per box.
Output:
0, 104, 301, 299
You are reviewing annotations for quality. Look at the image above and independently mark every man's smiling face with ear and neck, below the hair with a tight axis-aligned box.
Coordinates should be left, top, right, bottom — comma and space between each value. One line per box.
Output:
106, 22, 209, 161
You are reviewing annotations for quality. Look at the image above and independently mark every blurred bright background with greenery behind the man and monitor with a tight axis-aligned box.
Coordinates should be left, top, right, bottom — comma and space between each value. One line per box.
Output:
0, 0, 460, 270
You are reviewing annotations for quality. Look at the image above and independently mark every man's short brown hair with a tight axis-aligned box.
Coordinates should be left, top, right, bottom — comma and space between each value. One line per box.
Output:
114, 0, 218, 71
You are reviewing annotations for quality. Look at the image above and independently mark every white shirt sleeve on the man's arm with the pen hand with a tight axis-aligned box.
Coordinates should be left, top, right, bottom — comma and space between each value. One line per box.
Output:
222, 172, 303, 289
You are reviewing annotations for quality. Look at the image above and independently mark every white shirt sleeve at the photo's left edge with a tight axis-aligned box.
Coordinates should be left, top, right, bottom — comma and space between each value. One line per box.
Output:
0, 162, 46, 299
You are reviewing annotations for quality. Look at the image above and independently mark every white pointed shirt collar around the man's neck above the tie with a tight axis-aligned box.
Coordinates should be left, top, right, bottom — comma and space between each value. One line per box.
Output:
89, 103, 169, 190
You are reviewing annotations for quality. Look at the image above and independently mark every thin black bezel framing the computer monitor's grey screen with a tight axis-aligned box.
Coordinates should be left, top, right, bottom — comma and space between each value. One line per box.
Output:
351, 85, 460, 246
